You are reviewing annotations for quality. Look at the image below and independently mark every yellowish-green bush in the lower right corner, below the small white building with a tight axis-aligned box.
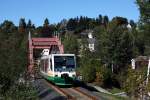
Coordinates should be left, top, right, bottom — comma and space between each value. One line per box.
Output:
124, 67, 147, 97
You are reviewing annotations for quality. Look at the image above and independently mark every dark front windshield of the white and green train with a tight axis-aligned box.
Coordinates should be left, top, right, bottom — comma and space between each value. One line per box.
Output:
54, 56, 75, 71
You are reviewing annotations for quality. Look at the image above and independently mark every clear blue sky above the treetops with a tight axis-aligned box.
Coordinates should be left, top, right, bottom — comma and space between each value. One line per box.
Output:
0, 0, 140, 26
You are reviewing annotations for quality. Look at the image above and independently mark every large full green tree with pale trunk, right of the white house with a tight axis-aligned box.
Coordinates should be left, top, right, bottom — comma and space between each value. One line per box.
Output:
94, 18, 135, 87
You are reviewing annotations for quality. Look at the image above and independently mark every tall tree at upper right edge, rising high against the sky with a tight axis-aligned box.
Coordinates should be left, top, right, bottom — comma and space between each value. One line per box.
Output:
136, 0, 150, 55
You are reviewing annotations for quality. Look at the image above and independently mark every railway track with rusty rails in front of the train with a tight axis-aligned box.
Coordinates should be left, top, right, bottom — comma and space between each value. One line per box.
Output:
45, 81, 98, 100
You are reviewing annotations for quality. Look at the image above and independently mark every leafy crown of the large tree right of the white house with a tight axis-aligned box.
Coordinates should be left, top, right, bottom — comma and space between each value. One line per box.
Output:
95, 17, 134, 71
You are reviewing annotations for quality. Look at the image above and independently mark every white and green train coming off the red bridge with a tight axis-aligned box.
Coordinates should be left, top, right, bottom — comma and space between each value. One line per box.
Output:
39, 50, 76, 85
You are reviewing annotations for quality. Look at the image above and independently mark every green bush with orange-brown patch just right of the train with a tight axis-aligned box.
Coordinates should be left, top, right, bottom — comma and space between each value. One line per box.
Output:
79, 49, 103, 85
